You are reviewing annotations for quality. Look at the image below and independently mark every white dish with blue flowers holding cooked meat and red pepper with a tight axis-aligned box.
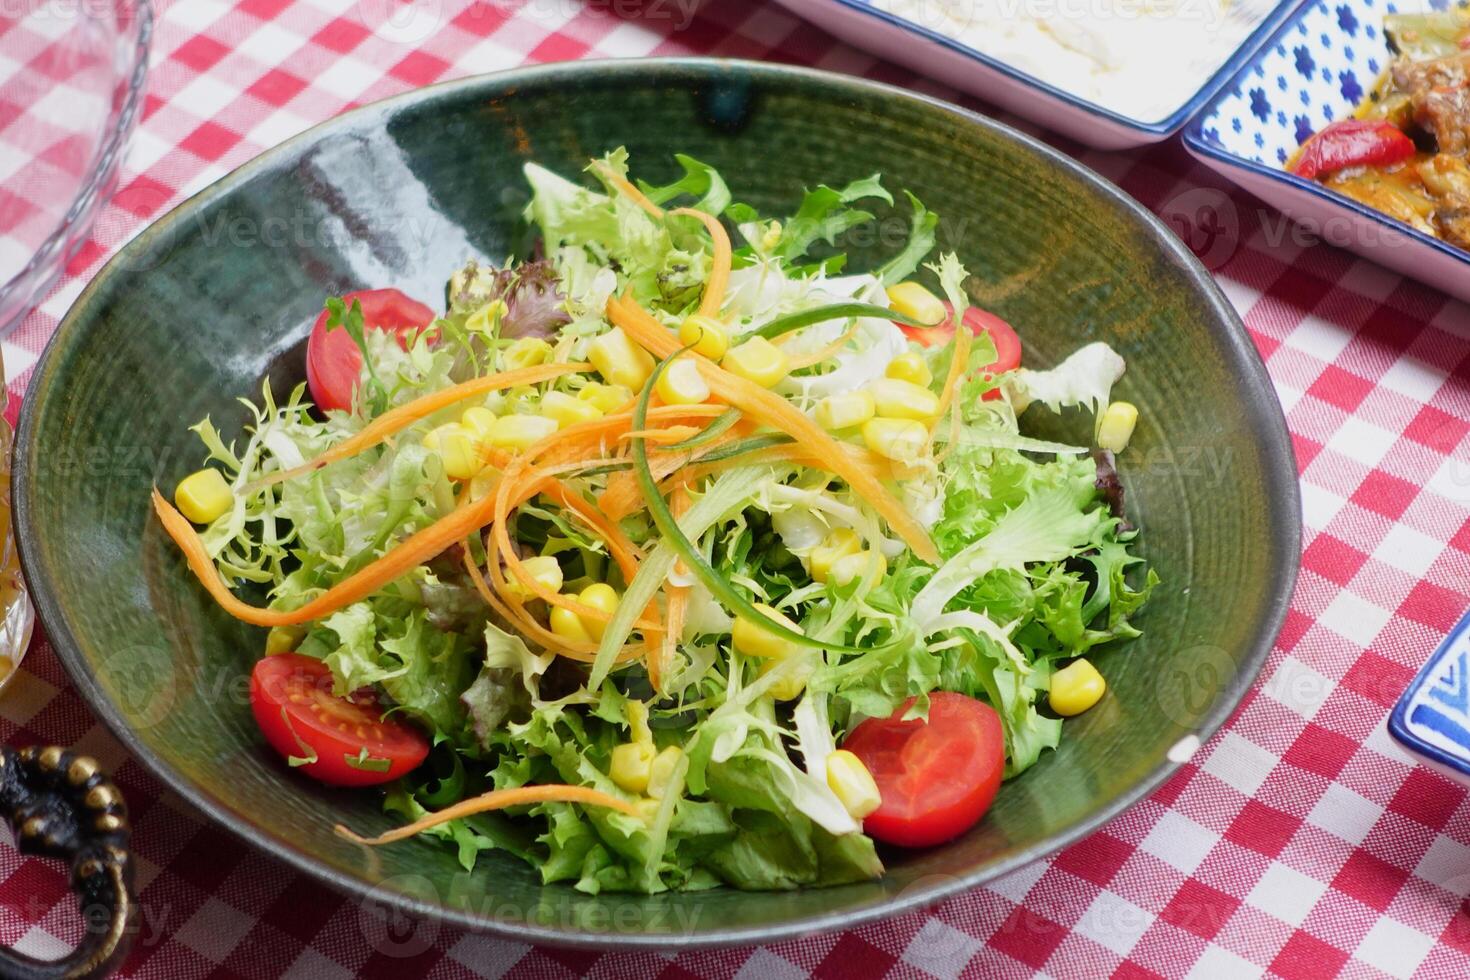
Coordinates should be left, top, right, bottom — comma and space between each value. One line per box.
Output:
1183, 0, 1470, 300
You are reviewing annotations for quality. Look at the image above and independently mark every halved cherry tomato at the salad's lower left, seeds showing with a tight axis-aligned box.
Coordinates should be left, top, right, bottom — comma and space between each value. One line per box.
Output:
250, 654, 429, 786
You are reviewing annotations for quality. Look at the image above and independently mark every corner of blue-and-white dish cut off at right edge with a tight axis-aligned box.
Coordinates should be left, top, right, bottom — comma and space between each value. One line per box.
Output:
1388, 613, 1470, 783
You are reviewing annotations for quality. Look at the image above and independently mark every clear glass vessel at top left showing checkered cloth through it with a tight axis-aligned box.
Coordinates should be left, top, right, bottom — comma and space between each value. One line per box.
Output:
0, 0, 153, 335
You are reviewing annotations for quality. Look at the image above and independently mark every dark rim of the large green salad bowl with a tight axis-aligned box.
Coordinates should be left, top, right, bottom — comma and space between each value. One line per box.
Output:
12, 57, 1301, 949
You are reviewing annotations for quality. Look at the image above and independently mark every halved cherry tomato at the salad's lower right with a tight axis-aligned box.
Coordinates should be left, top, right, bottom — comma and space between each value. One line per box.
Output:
842, 691, 1005, 848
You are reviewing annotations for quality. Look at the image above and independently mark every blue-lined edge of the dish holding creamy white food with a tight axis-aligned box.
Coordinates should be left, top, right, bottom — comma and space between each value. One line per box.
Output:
828, 0, 1313, 140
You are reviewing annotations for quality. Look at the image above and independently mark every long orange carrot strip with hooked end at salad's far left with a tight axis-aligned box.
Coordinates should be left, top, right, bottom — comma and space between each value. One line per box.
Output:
153, 488, 495, 626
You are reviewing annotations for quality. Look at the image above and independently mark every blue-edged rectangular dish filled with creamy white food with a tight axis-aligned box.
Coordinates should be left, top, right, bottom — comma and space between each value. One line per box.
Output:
778, 0, 1301, 150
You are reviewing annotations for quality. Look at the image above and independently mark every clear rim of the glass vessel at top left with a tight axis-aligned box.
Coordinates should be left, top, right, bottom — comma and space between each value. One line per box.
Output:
0, 0, 154, 335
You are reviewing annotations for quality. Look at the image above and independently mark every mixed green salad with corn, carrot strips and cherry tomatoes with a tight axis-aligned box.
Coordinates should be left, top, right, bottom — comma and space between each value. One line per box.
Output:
154, 150, 1155, 893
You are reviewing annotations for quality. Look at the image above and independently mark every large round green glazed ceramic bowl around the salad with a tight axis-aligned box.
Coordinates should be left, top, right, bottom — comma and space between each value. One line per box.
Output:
15, 60, 1299, 948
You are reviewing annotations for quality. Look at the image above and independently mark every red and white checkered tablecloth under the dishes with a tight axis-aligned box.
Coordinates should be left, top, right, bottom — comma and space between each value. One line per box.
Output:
0, 0, 1470, 980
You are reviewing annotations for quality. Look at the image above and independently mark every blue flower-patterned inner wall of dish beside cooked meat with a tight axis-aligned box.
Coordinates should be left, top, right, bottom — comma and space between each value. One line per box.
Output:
1200, 0, 1449, 166
